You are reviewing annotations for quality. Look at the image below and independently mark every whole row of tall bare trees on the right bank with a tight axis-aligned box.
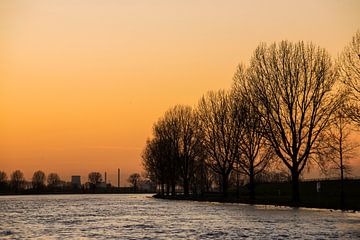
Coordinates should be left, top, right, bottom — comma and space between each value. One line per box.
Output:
142, 31, 360, 208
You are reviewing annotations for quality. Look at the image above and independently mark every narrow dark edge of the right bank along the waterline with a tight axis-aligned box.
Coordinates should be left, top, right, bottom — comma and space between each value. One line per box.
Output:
152, 194, 360, 213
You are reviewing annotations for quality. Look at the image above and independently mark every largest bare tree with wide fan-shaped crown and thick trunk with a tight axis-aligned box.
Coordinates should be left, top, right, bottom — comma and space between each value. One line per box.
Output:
249, 41, 340, 204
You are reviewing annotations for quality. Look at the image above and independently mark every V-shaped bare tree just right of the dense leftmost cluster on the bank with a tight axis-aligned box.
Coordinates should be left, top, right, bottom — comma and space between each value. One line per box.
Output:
198, 91, 245, 197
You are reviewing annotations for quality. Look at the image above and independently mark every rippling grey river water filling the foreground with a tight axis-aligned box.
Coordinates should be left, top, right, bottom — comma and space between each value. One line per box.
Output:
0, 195, 360, 239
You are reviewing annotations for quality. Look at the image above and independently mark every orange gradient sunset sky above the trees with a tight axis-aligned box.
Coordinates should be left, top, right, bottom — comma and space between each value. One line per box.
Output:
0, 0, 360, 183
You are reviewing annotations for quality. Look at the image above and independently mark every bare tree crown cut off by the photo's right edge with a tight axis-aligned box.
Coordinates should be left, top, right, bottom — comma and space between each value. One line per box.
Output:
338, 31, 360, 125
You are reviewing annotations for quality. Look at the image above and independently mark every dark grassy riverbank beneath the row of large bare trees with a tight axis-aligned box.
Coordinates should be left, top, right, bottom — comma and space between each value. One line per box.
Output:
154, 180, 360, 211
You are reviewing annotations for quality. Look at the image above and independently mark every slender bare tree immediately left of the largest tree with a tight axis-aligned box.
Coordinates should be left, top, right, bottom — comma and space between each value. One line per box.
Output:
232, 65, 274, 200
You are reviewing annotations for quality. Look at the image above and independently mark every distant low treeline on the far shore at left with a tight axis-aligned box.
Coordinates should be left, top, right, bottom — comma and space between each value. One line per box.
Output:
0, 170, 155, 194
